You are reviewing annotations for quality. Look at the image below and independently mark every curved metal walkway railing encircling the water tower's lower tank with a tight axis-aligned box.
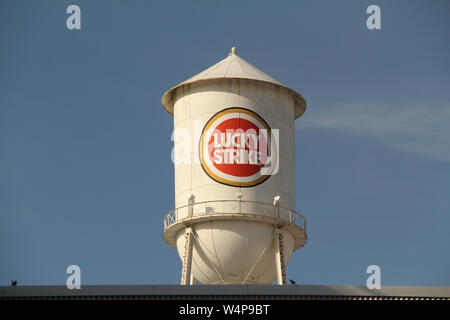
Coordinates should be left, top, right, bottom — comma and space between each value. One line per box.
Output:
164, 200, 306, 231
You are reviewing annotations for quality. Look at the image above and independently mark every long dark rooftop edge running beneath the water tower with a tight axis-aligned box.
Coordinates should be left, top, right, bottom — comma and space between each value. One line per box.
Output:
0, 285, 450, 298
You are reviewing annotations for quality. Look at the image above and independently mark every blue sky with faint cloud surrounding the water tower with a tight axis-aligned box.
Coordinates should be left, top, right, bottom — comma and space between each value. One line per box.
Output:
0, 0, 450, 286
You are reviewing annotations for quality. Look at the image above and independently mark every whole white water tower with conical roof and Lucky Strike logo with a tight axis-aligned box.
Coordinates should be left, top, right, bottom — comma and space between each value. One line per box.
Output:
162, 48, 306, 284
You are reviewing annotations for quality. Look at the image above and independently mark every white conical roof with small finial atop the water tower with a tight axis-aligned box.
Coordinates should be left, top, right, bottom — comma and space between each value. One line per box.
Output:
161, 47, 306, 118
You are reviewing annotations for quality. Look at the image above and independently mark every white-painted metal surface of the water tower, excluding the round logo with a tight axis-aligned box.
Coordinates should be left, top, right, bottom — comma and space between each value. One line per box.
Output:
162, 49, 306, 284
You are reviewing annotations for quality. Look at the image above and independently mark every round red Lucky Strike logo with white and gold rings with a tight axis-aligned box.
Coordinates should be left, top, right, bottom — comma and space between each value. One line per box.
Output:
200, 108, 276, 187
